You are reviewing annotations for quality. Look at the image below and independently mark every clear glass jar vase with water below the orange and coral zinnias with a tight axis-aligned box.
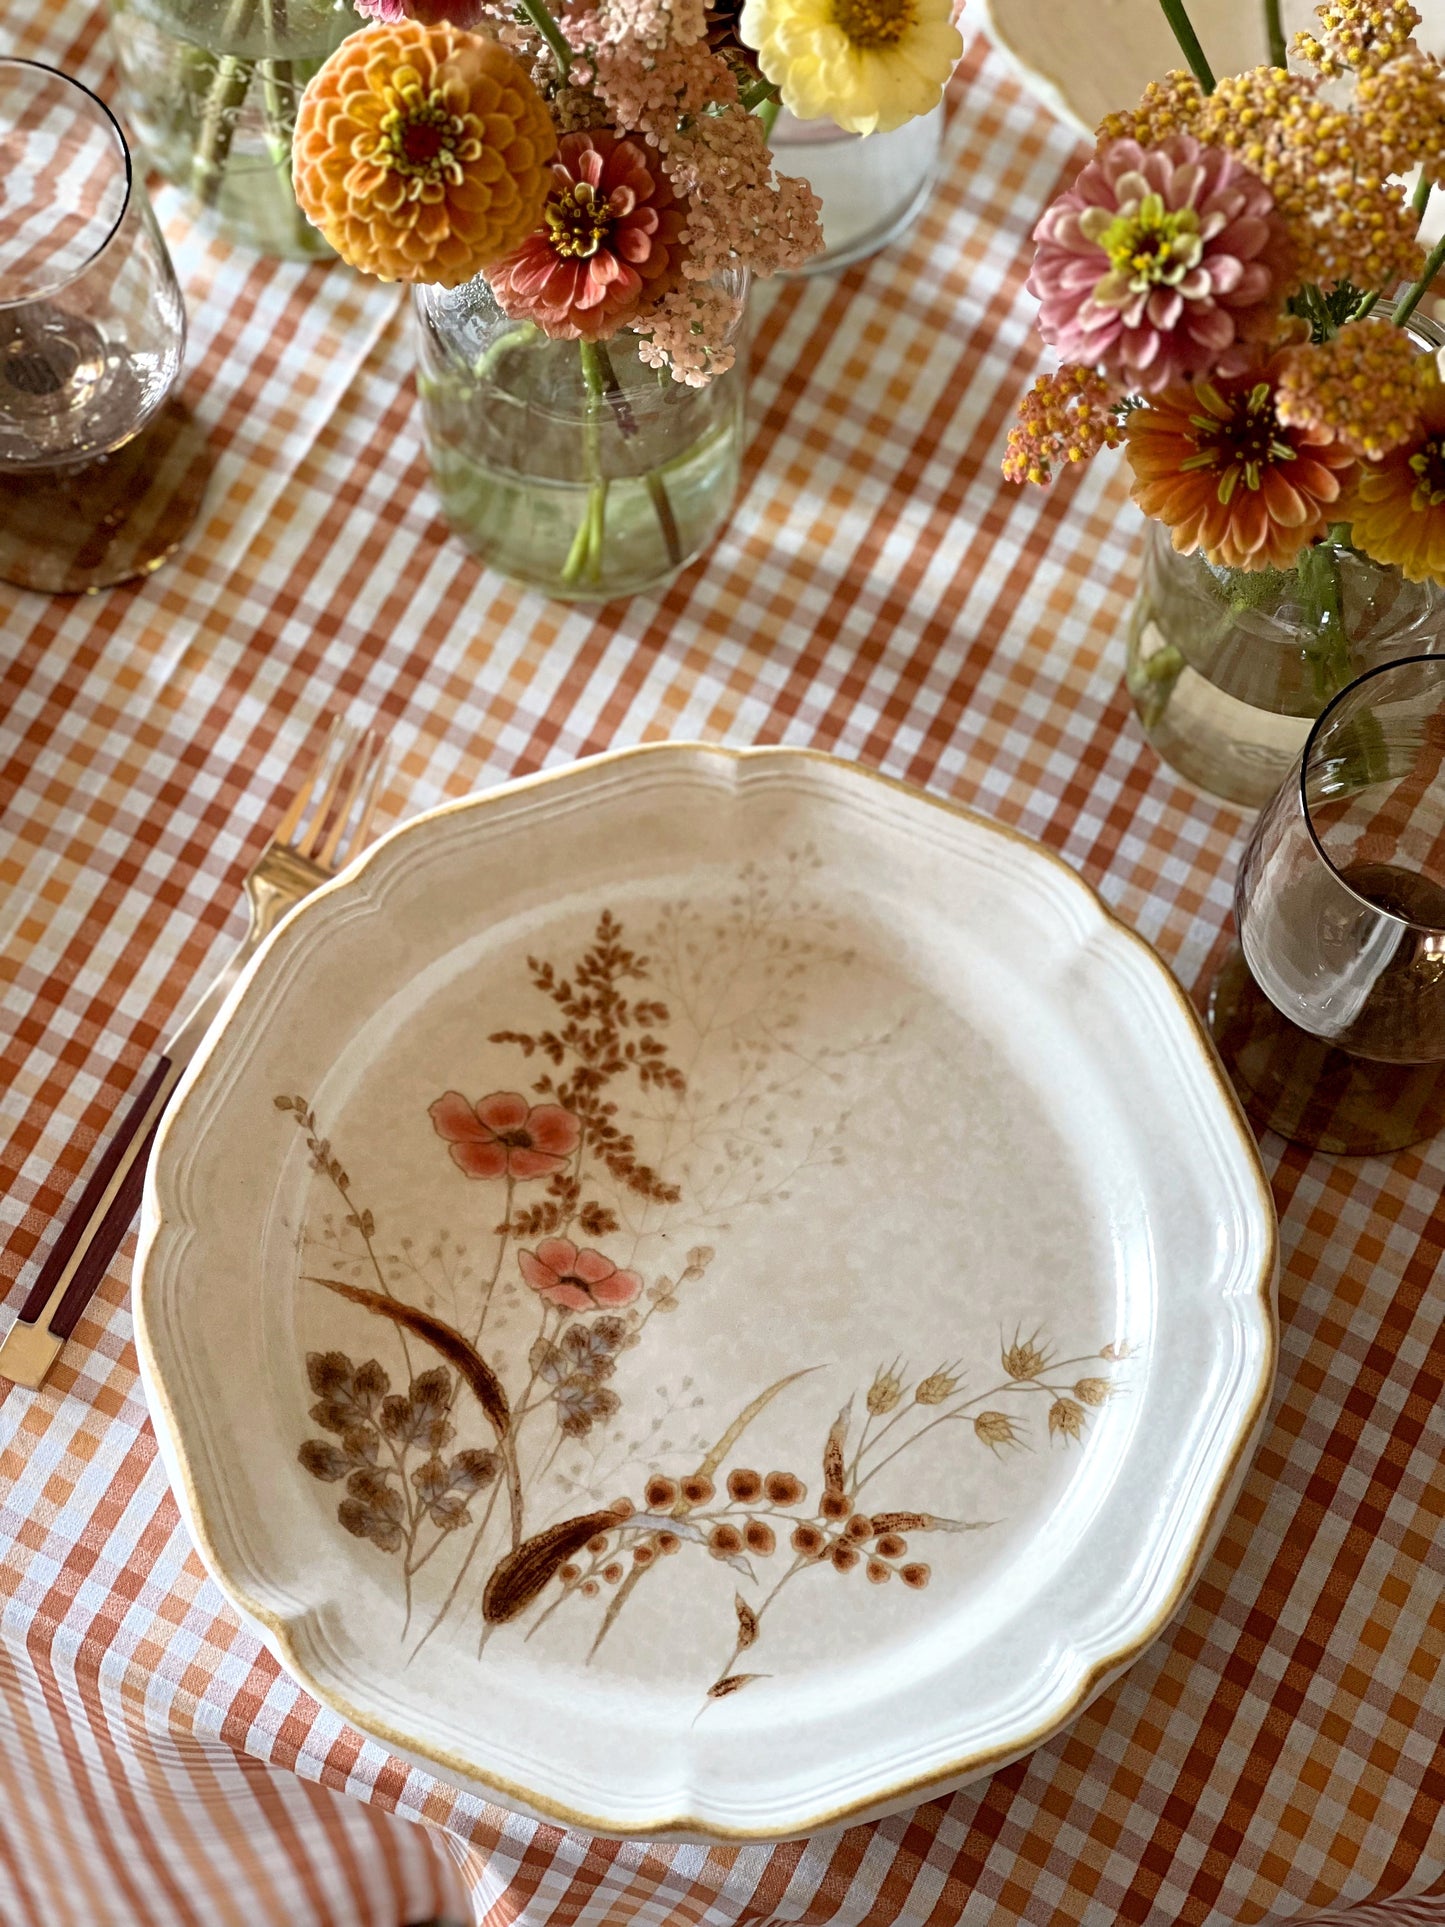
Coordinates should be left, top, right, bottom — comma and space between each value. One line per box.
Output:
414, 276, 748, 601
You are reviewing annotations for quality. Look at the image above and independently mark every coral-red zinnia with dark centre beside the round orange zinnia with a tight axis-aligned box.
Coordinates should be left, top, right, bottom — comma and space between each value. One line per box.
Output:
487, 127, 684, 341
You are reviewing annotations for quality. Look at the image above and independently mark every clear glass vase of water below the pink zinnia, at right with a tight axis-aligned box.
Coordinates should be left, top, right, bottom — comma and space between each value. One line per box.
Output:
1127, 522, 1445, 809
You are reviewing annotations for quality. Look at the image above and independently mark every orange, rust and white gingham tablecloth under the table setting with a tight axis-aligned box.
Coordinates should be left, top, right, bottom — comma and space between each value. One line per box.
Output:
0, 0, 1445, 1927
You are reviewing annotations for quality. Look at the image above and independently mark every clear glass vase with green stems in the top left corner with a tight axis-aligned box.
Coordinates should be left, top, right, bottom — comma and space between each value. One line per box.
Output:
108, 0, 360, 260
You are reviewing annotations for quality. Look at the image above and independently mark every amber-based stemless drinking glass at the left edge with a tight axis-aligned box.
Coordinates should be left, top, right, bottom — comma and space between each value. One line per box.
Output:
0, 60, 208, 590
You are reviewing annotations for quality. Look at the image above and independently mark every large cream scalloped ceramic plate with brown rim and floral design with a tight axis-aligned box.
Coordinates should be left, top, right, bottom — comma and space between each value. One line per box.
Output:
137, 746, 1275, 1838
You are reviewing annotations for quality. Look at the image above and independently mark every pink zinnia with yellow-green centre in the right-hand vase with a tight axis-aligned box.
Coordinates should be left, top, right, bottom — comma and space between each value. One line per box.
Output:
1029, 133, 1293, 393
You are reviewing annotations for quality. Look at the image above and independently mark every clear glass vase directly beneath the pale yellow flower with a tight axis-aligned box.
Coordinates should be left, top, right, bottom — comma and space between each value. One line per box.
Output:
771, 104, 944, 274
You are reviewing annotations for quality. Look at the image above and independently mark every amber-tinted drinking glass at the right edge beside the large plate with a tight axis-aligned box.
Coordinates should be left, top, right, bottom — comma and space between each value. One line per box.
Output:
1210, 655, 1445, 1152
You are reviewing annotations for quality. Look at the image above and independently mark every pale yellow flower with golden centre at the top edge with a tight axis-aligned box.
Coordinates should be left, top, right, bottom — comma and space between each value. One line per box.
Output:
740, 0, 963, 133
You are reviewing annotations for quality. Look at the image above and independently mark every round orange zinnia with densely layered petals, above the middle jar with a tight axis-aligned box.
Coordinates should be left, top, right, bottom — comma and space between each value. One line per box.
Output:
293, 19, 557, 287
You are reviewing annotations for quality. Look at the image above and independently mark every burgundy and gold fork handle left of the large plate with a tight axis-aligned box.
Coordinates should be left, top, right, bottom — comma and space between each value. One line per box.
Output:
0, 1056, 179, 1384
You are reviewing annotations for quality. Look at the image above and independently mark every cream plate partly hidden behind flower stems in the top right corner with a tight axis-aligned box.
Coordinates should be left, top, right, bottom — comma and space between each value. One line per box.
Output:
969, 0, 1445, 139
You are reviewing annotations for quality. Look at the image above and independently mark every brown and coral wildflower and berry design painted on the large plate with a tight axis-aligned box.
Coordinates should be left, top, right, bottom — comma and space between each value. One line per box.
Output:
285, 882, 1125, 1703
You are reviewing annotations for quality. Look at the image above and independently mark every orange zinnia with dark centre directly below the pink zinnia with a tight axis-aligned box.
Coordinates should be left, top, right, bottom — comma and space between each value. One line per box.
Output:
1123, 355, 1354, 568
